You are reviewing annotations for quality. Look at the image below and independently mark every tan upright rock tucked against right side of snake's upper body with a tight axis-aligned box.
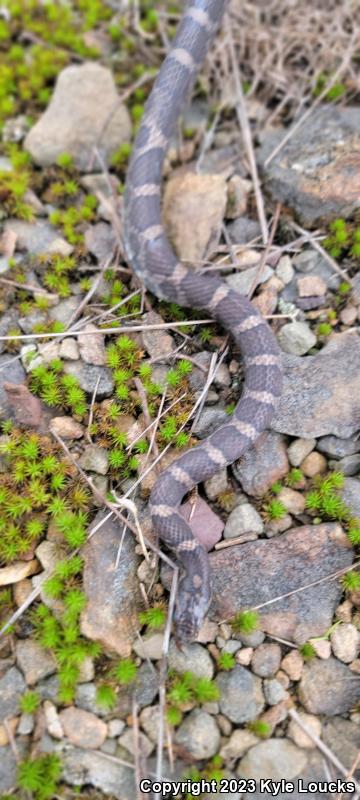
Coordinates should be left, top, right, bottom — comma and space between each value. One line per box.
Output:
163, 172, 227, 263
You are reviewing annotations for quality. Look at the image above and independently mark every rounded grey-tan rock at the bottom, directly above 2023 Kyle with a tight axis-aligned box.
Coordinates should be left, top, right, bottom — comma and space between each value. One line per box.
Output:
237, 739, 307, 780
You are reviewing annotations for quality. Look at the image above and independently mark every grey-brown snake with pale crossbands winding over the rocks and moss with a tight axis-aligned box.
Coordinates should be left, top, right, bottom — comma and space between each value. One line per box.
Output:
123, 0, 282, 643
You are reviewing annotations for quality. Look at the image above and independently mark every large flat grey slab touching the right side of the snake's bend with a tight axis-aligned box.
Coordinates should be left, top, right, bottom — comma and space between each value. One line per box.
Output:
271, 333, 360, 439
